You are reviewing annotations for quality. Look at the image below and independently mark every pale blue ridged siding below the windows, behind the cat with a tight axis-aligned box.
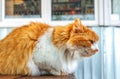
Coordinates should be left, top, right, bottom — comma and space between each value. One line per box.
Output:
0, 27, 120, 79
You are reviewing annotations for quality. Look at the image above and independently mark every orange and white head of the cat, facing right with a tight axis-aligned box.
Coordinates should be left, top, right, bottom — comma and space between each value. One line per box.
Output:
67, 19, 99, 58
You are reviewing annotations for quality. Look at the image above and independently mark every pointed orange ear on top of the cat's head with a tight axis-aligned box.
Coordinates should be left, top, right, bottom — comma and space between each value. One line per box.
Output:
73, 18, 83, 33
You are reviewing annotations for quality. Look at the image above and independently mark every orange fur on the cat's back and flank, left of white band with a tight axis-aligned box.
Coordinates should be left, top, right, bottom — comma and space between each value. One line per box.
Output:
0, 23, 49, 75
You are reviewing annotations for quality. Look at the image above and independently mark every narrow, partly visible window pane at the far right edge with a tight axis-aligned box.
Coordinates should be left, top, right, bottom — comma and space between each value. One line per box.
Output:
111, 0, 120, 20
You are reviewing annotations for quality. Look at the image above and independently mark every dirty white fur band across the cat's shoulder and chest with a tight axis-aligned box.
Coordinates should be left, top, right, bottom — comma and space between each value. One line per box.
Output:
28, 28, 77, 75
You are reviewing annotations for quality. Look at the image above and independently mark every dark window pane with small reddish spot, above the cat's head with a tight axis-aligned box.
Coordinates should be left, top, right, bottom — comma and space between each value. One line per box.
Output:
52, 0, 95, 20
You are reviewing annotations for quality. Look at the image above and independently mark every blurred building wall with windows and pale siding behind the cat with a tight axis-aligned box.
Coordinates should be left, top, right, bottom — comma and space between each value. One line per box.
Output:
0, 0, 120, 79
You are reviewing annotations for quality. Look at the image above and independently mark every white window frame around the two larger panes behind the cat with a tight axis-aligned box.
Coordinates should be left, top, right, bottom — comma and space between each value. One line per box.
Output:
0, 0, 109, 27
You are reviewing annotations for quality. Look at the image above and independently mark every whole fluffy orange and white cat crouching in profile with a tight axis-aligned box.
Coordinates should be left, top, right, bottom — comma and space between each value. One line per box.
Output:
0, 19, 99, 76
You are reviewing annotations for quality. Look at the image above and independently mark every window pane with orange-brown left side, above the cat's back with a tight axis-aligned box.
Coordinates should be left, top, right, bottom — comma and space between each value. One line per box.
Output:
5, 0, 41, 18
